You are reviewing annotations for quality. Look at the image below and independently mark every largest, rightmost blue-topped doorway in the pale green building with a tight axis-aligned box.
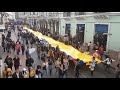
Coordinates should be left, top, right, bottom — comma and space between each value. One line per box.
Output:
94, 24, 108, 50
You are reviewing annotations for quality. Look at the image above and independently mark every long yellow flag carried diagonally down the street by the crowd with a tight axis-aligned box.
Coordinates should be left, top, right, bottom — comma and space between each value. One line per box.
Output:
23, 26, 101, 65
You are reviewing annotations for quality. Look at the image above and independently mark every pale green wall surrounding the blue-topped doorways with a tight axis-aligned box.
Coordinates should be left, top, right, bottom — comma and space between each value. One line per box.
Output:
59, 16, 120, 51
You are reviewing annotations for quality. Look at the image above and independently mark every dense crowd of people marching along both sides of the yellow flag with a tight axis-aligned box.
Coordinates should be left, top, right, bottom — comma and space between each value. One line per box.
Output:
2, 22, 120, 78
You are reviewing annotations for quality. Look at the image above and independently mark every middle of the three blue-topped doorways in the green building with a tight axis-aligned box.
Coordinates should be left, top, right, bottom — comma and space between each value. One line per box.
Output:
76, 24, 85, 43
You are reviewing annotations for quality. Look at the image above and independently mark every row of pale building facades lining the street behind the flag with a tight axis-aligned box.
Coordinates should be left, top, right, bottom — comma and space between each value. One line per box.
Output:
16, 12, 120, 52
